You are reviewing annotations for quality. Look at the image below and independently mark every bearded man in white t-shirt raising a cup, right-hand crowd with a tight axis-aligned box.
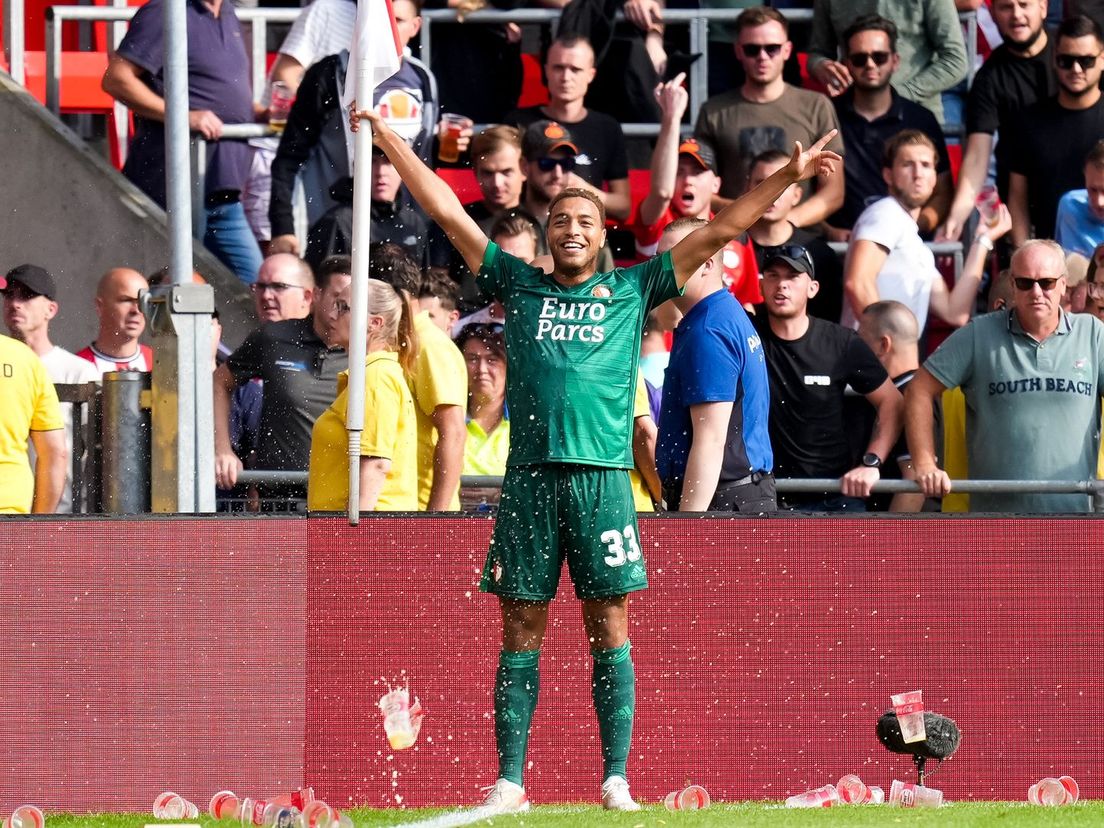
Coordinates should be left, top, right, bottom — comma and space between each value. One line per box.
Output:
841, 129, 992, 331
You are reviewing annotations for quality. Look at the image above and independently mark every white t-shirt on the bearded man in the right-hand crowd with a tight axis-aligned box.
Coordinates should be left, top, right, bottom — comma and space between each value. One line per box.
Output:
840, 195, 943, 331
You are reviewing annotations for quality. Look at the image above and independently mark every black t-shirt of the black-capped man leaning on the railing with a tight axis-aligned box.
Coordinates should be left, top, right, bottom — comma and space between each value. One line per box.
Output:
755, 314, 889, 483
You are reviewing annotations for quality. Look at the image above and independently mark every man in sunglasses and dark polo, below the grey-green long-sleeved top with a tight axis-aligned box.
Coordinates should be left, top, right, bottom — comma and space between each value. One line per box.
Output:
828, 14, 955, 241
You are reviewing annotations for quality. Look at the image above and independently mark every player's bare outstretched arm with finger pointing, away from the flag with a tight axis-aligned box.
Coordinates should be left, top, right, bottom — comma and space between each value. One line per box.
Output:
671, 129, 843, 287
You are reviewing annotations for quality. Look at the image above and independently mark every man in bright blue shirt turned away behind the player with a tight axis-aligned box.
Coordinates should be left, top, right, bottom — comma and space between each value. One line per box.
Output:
656, 217, 778, 514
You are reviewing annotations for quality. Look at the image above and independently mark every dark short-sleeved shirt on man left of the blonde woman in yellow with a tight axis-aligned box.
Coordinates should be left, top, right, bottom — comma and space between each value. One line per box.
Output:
226, 316, 349, 471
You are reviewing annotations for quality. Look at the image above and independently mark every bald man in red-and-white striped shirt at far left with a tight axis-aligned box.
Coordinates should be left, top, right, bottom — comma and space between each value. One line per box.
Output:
76, 267, 153, 375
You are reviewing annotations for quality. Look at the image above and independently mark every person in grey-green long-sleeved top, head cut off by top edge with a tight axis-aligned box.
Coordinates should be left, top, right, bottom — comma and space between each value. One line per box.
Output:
809, 0, 967, 121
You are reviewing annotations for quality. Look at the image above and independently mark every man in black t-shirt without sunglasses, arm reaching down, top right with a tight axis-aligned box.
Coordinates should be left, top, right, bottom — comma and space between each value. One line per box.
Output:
940, 0, 1058, 242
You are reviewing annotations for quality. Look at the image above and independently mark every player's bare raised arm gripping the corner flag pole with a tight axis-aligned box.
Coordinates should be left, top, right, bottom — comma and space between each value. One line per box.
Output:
349, 103, 488, 273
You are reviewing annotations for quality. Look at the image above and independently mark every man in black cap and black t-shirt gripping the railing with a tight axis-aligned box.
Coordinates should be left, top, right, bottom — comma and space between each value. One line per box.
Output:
755, 245, 904, 512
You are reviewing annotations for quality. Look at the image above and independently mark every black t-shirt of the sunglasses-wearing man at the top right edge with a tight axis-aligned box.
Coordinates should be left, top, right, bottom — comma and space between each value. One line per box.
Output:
1005, 96, 1104, 238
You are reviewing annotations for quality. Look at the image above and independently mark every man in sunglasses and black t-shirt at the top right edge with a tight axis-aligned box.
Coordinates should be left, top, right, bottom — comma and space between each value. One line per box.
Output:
1005, 14, 1104, 247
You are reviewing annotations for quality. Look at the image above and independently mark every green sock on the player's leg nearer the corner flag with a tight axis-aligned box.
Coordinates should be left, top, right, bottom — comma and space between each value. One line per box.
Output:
495, 649, 541, 785
